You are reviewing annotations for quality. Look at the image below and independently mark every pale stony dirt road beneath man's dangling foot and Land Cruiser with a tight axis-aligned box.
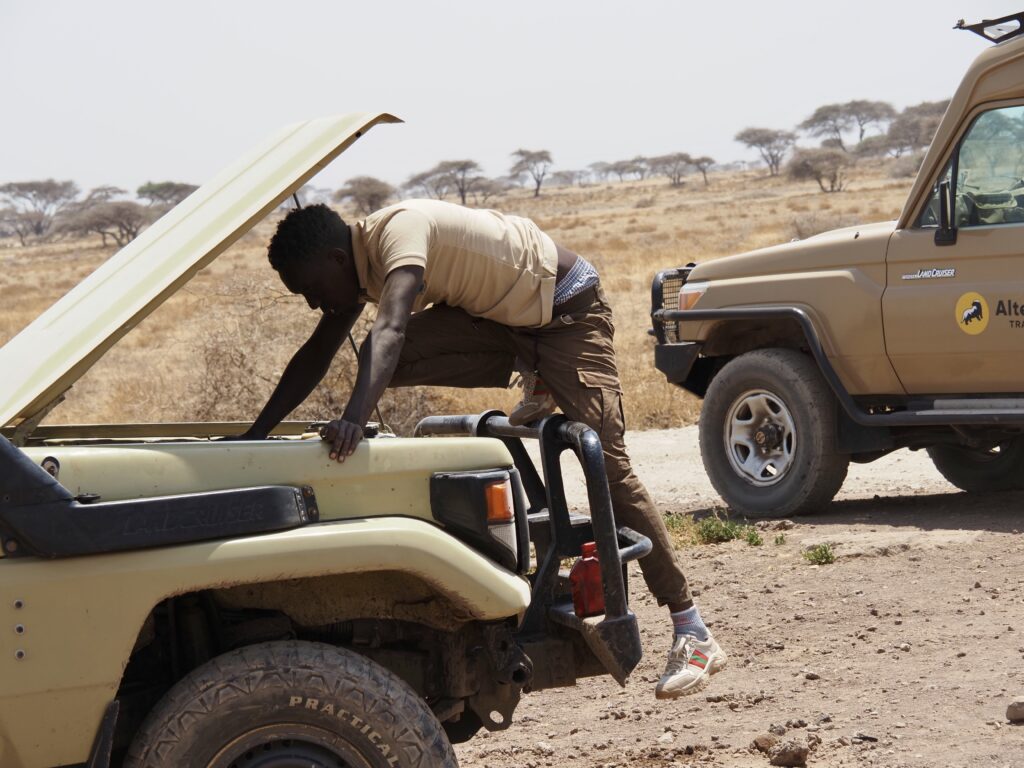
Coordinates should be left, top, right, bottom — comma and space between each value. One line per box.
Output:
458, 428, 1024, 768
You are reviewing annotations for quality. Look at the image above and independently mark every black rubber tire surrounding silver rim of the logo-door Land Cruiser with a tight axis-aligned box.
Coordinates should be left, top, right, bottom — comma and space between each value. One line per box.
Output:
699, 349, 850, 518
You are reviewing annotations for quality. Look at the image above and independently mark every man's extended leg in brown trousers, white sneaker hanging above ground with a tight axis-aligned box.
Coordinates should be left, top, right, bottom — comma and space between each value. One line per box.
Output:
517, 290, 725, 697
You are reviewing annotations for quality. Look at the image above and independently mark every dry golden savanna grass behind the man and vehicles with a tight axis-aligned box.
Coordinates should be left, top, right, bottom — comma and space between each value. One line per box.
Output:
0, 161, 911, 433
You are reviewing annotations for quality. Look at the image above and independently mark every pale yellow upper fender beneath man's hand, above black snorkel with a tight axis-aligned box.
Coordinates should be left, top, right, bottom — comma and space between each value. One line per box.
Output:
25, 437, 520, 520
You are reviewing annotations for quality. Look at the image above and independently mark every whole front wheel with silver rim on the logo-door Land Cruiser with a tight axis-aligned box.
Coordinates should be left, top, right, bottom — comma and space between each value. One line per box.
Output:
699, 349, 850, 517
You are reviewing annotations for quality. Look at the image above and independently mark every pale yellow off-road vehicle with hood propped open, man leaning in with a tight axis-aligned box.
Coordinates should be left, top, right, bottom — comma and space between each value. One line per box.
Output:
0, 115, 650, 768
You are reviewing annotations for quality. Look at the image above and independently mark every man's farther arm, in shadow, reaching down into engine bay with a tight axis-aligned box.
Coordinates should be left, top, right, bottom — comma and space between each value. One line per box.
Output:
240, 304, 364, 440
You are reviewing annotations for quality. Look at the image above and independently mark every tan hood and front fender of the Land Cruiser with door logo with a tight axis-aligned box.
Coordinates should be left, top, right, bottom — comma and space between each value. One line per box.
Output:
680, 225, 902, 394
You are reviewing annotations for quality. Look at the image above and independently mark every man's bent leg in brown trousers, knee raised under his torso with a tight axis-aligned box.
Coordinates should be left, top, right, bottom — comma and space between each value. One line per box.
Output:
390, 304, 515, 387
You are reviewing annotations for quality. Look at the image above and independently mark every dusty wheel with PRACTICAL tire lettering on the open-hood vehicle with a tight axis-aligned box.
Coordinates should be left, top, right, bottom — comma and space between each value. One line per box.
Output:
124, 641, 458, 768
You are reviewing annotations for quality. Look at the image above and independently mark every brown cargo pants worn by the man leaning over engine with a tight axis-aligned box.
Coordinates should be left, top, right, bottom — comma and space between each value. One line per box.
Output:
391, 286, 693, 608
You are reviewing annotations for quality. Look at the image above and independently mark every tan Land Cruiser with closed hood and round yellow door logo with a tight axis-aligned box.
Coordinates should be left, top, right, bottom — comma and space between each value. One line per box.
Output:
651, 13, 1024, 517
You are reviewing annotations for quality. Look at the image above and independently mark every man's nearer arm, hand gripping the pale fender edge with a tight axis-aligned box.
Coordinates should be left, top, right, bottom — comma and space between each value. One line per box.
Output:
324, 266, 423, 462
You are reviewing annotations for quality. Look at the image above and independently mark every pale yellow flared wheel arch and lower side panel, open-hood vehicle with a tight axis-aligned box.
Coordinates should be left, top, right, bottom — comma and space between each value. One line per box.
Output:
0, 518, 530, 768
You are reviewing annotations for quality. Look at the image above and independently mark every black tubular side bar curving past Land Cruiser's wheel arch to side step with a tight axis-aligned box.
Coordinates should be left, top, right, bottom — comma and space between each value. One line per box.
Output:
651, 306, 1024, 427
